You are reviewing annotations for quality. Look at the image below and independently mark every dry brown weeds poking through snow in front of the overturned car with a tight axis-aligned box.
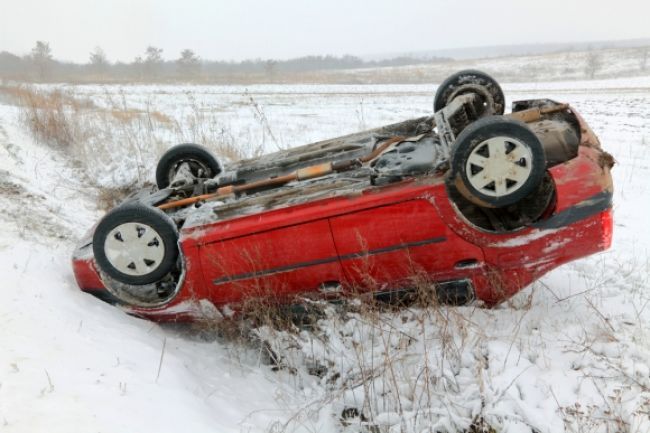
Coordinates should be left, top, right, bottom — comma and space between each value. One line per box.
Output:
182, 264, 650, 433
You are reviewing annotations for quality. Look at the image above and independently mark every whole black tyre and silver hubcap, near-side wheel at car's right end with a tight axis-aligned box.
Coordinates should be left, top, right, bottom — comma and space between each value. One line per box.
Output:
447, 116, 546, 208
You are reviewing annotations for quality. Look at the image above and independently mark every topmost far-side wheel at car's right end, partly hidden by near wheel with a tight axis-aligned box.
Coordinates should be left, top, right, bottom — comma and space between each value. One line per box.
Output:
433, 69, 506, 117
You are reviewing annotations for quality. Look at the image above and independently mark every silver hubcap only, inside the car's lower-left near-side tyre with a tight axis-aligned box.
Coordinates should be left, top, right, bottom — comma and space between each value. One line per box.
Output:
104, 223, 165, 276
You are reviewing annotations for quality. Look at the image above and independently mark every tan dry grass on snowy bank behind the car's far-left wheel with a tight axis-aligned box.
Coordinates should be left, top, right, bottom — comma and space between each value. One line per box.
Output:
0, 86, 270, 194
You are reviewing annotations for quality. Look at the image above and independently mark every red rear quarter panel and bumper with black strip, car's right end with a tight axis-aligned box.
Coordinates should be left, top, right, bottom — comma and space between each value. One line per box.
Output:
477, 139, 614, 304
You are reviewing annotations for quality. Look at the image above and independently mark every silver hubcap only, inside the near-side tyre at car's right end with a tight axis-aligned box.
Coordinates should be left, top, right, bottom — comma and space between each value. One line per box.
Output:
465, 136, 533, 198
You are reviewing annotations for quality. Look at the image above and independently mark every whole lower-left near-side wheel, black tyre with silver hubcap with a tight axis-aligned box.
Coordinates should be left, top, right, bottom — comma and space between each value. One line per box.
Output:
93, 203, 178, 285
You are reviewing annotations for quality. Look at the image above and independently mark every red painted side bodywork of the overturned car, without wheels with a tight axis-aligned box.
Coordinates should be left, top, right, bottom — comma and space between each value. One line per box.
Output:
73, 109, 613, 321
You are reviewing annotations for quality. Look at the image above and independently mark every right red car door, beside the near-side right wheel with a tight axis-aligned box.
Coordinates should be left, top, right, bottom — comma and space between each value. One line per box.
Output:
330, 198, 483, 290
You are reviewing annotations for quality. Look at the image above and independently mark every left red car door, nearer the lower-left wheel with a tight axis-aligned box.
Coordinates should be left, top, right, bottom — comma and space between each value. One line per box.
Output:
201, 219, 342, 304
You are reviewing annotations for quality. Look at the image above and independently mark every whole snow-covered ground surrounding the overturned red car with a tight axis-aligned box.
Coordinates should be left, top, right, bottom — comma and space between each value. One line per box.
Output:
0, 78, 650, 433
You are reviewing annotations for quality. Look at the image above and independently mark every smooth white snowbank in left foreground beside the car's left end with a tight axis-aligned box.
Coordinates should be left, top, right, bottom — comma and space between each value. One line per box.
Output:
0, 105, 302, 432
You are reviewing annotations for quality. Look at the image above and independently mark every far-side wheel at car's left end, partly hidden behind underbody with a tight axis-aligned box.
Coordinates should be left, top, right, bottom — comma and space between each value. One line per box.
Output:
156, 143, 221, 189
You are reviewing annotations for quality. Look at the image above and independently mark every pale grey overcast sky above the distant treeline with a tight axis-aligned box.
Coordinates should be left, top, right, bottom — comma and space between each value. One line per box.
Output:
0, 0, 650, 62
